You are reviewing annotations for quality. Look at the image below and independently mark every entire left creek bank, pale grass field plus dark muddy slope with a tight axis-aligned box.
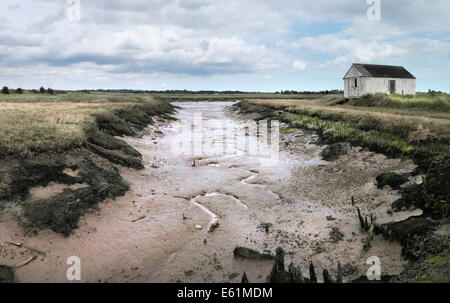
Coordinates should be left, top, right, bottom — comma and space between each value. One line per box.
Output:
0, 93, 173, 236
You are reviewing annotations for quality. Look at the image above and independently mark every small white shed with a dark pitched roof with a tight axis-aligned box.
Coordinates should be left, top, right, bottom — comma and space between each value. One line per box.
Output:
344, 63, 416, 98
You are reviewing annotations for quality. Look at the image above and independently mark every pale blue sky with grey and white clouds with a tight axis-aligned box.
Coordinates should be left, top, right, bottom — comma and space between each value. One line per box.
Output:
0, 0, 450, 92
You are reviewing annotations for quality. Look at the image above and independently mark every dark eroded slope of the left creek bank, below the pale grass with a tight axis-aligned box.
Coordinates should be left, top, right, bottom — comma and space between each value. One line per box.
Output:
0, 103, 174, 236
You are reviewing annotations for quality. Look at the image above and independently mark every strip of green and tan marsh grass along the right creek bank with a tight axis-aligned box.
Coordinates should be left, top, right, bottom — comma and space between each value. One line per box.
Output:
239, 99, 450, 167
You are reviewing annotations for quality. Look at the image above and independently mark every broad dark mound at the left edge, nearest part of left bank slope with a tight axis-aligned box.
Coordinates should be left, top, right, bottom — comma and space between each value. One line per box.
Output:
0, 150, 128, 236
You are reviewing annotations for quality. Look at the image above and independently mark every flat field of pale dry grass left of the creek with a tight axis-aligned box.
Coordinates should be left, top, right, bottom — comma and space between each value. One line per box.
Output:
0, 93, 167, 158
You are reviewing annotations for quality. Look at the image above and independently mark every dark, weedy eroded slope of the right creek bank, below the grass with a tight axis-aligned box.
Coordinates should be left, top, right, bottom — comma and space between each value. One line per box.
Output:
233, 101, 450, 282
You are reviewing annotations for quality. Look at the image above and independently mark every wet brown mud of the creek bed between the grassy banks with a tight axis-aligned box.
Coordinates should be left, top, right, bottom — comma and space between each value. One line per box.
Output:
0, 102, 432, 282
